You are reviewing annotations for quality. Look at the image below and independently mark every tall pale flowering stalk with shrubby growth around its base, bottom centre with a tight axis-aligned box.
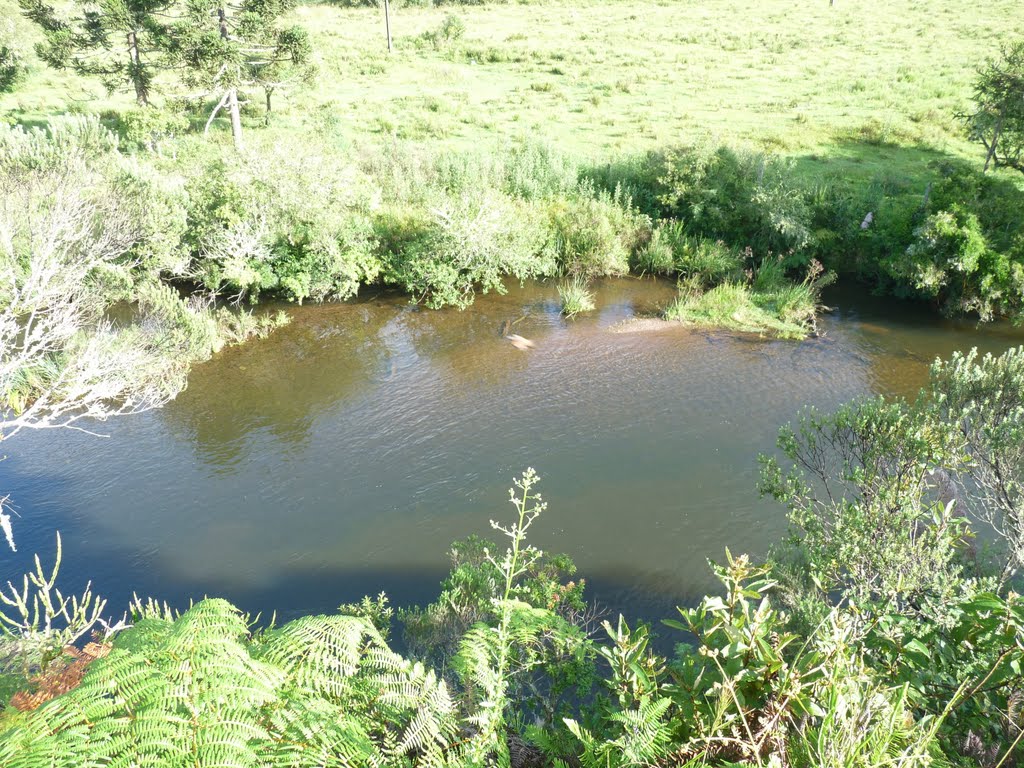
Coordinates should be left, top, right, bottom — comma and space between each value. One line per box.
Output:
404, 469, 593, 765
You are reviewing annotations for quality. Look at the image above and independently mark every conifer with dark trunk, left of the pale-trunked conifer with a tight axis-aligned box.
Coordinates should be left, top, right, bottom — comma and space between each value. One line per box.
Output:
18, 0, 173, 105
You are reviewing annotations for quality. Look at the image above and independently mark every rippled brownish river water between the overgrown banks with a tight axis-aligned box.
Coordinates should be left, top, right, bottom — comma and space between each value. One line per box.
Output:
0, 280, 1024, 617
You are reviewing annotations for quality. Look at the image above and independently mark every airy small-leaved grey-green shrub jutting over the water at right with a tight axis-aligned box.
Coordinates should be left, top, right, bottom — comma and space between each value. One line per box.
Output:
761, 398, 966, 611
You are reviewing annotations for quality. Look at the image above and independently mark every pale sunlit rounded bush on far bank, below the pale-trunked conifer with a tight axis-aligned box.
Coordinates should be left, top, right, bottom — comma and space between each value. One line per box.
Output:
187, 142, 380, 302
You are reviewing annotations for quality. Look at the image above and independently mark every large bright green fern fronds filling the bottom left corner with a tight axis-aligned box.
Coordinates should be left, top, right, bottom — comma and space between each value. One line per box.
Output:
0, 600, 457, 768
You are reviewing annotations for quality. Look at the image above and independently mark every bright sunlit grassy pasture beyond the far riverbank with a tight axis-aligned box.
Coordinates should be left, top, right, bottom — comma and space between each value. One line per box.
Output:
8, 0, 1024, 186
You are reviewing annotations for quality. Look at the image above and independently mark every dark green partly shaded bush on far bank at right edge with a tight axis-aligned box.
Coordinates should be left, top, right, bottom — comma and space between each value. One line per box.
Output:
812, 162, 1024, 321
